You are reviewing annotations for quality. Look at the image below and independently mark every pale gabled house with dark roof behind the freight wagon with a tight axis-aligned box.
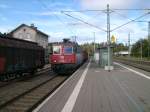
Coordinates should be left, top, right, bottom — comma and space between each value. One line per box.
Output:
9, 24, 48, 49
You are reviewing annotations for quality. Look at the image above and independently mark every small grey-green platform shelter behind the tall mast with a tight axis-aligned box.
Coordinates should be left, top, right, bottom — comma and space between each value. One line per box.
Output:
99, 47, 113, 68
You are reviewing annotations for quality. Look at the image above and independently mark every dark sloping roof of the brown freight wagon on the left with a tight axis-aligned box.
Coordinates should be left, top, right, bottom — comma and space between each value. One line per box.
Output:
0, 35, 42, 49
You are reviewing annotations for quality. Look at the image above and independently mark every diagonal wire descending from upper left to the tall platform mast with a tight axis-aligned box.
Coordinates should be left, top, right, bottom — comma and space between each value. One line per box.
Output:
61, 11, 107, 32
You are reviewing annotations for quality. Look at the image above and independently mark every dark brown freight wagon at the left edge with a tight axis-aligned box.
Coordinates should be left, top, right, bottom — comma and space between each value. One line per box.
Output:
0, 35, 45, 80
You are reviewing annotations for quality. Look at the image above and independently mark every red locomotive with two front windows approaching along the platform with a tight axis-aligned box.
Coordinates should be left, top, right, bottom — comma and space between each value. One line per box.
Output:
50, 39, 88, 74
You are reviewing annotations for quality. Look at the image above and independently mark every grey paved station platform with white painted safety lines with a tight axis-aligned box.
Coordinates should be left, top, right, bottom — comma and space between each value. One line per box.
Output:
33, 61, 150, 112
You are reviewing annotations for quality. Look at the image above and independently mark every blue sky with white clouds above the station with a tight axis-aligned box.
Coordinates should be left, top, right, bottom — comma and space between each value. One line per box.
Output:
0, 0, 150, 44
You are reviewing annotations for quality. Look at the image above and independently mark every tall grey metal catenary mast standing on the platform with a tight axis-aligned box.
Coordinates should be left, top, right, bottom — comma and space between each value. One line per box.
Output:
107, 4, 111, 71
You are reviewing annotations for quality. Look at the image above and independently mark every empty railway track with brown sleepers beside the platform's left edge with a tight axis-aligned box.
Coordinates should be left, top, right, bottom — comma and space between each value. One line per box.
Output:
0, 69, 68, 112
